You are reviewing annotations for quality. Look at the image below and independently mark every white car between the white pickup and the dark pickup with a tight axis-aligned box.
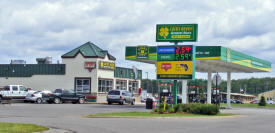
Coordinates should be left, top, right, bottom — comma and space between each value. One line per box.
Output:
26, 91, 52, 104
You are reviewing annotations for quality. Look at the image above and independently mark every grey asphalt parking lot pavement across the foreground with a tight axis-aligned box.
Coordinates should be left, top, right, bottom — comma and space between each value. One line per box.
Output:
0, 103, 275, 133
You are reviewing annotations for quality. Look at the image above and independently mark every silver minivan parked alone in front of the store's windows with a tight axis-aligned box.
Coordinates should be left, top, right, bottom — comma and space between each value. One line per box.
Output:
107, 90, 135, 105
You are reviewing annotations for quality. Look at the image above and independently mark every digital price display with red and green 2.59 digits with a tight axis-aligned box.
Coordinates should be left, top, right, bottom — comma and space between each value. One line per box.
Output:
175, 46, 193, 61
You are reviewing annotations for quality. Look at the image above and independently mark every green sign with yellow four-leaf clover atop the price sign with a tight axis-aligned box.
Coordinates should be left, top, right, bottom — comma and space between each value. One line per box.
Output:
156, 24, 198, 42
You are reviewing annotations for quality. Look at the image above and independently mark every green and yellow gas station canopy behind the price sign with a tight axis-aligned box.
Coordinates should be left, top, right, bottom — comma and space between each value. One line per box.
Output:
125, 46, 271, 73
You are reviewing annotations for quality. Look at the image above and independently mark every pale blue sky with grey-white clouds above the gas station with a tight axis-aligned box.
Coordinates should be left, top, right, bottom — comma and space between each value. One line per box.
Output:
0, 0, 275, 79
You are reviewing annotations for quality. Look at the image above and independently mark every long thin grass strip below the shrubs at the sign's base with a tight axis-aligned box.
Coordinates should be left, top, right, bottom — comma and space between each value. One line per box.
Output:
86, 112, 234, 118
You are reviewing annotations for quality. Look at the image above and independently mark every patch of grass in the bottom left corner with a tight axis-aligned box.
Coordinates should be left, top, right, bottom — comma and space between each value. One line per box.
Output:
0, 122, 49, 133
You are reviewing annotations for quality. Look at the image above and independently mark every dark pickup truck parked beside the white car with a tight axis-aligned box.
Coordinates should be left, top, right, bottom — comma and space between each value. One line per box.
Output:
42, 89, 86, 104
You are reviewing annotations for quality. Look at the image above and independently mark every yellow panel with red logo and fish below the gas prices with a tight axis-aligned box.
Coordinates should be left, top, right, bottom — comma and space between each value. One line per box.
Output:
157, 61, 193, 75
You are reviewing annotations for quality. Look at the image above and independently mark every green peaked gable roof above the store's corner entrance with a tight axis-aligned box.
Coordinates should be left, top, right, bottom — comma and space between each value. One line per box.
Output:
61, 42, 116, 60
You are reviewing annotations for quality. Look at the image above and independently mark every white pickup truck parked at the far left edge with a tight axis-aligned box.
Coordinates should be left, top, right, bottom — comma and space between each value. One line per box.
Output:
0, 85, 34, 101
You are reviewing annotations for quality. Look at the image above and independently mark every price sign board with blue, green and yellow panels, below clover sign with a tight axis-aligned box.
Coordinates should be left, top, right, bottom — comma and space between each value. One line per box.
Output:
157, 45, 196, 79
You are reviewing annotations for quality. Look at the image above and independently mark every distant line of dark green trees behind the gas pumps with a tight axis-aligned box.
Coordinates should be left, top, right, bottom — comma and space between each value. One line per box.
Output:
141, 77, 275, 95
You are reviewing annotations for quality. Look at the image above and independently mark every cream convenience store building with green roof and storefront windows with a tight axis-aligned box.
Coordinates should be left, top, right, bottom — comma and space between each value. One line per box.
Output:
0, 42, 142, 103
